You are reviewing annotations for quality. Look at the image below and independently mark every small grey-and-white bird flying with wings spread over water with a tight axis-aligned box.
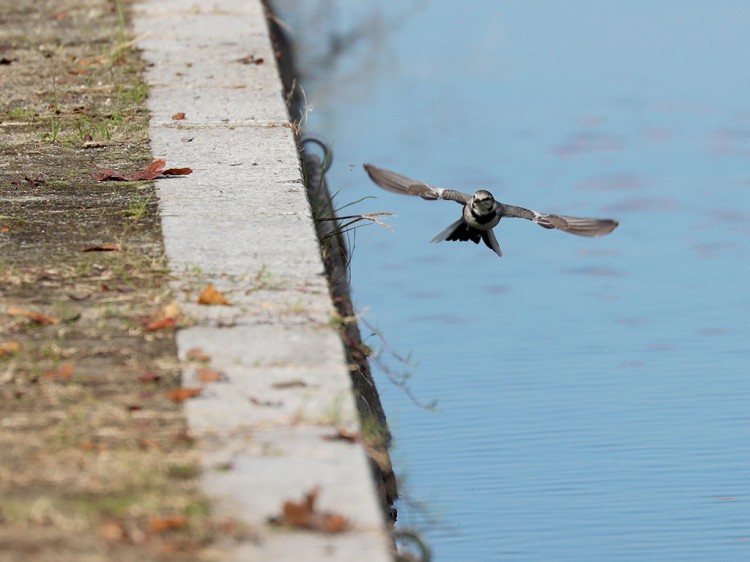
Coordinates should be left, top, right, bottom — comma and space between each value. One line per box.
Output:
364, 164, 620, 257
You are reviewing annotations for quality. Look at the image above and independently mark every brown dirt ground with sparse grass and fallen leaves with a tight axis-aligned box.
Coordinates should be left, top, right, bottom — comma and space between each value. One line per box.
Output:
0, 0, 250, 562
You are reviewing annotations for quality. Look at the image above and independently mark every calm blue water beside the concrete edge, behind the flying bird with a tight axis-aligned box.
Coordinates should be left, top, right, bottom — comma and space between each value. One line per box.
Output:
277, 0, 750, 561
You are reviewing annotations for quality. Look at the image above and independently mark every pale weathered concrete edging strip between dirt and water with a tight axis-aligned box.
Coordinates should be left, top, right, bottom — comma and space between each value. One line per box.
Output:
134, 0, 391, 562
